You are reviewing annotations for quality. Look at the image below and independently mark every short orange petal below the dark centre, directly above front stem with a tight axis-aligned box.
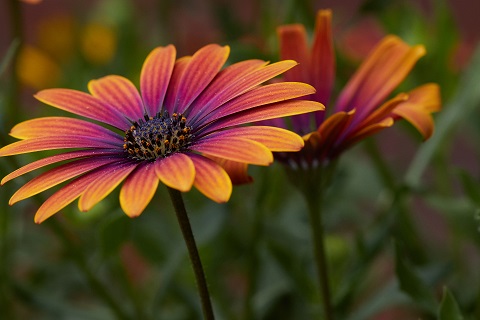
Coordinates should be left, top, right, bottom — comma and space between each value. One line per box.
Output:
155, 153, 195, 192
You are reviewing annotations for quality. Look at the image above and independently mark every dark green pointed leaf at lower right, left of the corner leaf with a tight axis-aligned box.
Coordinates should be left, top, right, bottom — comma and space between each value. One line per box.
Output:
395, 245, 438, 315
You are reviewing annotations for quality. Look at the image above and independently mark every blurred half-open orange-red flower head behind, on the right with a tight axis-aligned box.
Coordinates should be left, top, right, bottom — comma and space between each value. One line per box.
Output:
270, 10, 440, 166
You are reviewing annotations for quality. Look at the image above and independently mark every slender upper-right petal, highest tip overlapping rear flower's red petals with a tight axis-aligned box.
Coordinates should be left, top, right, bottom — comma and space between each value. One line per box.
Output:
188, 60, 297, 122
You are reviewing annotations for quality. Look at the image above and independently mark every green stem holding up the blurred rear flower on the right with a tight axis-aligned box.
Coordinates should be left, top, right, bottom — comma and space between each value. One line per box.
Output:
305, 183, 333, 320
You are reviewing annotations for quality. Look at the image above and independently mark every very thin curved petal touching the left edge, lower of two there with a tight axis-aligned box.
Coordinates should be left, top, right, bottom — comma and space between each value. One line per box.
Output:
0, 149, 118, 185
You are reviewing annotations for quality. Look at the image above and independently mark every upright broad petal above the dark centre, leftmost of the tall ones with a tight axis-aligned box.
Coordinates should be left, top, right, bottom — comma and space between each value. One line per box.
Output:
140, 45, 177, 116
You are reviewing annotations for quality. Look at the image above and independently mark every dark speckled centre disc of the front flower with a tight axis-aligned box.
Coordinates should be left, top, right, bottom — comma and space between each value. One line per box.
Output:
123, 111, 193, 160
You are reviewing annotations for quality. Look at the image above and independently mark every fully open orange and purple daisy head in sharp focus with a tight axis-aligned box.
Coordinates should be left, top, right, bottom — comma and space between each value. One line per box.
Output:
0, 44, 323, 223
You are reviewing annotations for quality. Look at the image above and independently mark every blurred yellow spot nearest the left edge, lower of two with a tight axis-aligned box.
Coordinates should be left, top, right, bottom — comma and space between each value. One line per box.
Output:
16, 45, 61, 90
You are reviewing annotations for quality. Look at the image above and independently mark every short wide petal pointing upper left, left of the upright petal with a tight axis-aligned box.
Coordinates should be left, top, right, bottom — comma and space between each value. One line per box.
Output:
88, 75, 145, 121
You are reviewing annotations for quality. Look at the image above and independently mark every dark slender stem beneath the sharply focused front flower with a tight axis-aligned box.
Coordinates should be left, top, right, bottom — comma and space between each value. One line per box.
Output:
168, 187, 214, 320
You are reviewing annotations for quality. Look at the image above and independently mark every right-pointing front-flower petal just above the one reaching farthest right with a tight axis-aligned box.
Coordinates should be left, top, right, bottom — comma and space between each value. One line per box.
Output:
191, 82, 315, 126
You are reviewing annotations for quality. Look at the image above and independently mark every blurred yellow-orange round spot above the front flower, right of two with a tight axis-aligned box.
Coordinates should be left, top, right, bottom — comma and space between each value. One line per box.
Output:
81, 22, 117, 65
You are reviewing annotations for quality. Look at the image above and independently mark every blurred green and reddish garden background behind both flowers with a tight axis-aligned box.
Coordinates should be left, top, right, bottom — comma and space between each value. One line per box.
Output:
0, 0, 480, 320
